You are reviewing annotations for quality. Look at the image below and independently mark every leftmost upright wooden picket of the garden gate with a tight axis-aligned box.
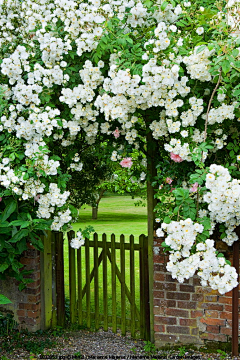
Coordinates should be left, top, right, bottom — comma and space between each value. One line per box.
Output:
67, 230, 76, 323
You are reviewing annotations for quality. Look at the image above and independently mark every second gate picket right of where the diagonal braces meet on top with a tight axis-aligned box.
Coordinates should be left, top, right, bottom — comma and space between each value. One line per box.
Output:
120, 235, 126, 336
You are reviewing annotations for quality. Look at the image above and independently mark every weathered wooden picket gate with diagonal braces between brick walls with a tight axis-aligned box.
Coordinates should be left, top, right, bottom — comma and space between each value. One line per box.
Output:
68, 231, 150, 340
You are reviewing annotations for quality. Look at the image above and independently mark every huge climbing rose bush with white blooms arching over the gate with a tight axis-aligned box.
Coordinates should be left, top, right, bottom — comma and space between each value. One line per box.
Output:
0, 0, 240, 293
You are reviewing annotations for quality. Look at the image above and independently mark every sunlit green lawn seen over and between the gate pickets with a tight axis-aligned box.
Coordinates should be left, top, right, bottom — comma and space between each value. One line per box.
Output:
64, 196, 147, 330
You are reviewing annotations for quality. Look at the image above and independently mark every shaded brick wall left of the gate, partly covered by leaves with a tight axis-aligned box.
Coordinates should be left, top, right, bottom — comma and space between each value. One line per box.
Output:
0, 245, 41, 331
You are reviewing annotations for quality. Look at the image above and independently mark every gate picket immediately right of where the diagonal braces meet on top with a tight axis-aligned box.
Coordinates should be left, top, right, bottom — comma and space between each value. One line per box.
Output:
109, 234, 117, 334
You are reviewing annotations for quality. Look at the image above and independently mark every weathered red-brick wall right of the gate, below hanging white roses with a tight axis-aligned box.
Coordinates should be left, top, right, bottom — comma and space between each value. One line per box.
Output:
153, 238, 240, 347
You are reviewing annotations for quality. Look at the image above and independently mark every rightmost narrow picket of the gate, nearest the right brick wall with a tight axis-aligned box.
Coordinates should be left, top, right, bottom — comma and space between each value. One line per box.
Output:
139, 235, 145, 338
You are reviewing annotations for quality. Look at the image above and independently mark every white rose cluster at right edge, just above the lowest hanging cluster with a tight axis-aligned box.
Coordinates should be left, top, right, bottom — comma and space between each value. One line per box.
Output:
203, 164, 240, 246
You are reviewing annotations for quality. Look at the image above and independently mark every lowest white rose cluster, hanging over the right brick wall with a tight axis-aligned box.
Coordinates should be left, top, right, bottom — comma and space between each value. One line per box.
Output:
157, 219, 238, 294
